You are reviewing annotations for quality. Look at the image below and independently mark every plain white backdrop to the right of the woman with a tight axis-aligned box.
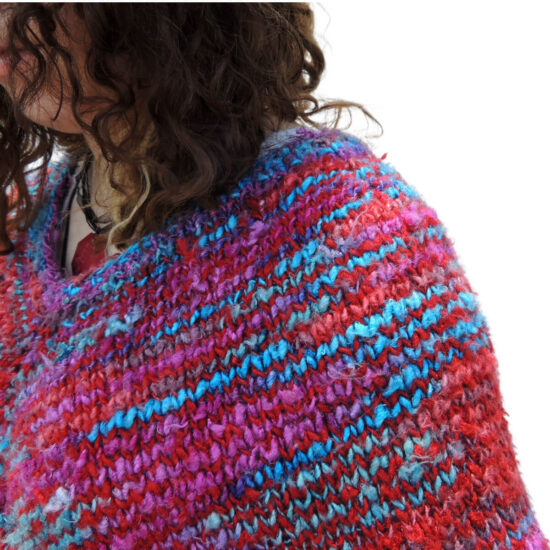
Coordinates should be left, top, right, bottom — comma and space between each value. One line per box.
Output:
311, 0, 550, 537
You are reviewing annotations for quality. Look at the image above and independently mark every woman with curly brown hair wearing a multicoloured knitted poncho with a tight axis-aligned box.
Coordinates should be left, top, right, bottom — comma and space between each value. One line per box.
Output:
0, 3, 548, 550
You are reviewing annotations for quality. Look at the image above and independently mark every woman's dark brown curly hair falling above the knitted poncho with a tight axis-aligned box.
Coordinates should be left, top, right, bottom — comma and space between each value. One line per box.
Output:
0, 3, 382, 254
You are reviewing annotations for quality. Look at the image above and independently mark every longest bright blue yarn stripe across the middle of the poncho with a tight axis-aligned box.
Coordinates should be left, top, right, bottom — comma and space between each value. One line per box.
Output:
88, 284, 482, 442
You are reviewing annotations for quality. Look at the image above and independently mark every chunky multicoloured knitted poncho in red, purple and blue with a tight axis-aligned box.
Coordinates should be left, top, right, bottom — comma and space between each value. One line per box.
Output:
0, 127, 548, 550
